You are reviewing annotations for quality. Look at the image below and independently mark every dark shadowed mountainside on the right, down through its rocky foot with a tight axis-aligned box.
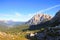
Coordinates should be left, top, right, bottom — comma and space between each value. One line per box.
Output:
30, 10, 60, 40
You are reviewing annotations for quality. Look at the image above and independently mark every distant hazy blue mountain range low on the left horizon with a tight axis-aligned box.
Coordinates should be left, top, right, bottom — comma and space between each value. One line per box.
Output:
0, 20, 24, 27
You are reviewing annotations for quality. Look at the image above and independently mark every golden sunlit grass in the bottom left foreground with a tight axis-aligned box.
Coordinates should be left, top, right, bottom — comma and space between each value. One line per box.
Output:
0, 32, 27, 40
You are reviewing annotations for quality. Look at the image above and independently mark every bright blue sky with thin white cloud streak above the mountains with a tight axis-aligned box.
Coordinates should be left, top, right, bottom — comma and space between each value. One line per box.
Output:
0, 0, 60, 21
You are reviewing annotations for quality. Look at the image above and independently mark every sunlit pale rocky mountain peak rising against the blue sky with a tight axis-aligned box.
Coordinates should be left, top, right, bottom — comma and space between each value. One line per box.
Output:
27, 14, 52, 25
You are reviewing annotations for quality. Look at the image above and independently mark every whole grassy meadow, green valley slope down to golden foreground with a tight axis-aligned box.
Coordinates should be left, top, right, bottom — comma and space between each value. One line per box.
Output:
0, 25, 38, 40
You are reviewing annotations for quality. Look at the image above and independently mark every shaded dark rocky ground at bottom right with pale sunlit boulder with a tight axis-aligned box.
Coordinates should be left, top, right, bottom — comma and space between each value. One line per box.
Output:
29, 26, 60, 40
